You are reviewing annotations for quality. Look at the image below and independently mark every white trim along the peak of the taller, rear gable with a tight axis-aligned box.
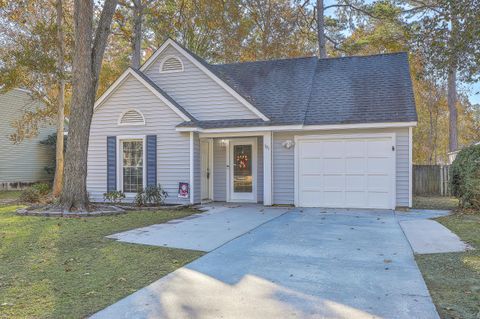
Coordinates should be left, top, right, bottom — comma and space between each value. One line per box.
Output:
140, 39, 270, 121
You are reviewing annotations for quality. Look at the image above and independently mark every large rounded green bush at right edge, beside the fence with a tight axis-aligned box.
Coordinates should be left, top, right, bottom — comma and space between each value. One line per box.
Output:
450, 145, 480, 209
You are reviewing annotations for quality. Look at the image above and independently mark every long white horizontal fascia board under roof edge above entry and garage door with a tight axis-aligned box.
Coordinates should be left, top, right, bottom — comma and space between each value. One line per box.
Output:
182, 122, 417, 137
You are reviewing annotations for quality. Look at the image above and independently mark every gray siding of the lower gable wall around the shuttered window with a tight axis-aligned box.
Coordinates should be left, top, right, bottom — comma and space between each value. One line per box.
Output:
87, 75, 190, 203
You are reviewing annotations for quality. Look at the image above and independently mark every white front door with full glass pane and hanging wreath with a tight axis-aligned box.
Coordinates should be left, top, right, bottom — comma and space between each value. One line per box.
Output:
229, 138, 257, 202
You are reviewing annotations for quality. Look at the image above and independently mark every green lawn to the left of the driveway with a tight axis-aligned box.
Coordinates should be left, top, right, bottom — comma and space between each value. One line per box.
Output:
0, 206, 202, 319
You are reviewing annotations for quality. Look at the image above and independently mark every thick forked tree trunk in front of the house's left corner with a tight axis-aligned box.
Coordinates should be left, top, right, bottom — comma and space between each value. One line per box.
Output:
60, 0, 117, 211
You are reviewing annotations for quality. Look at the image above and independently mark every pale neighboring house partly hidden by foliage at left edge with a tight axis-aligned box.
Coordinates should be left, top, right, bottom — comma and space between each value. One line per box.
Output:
0, 89, 55, 190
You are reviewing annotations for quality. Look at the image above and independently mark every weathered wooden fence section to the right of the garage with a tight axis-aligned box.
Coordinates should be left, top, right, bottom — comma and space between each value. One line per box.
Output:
412, 165, 450, 196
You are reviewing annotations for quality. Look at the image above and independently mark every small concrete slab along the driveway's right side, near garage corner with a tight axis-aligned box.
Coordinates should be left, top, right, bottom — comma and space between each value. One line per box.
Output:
397, 210, 471, 254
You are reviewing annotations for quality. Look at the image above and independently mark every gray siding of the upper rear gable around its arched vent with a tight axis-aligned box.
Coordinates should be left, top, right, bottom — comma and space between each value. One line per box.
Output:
144, 45, 258, 120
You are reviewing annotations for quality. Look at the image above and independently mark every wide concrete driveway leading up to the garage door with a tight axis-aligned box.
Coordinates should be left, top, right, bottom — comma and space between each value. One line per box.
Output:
93, 209, 438, 319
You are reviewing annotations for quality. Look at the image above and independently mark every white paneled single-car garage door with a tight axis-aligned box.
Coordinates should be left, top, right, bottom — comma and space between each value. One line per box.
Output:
297, 136, 395, 209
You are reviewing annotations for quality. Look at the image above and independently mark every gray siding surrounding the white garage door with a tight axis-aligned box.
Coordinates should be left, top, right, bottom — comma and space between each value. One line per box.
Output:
273, 128, 409, 206
